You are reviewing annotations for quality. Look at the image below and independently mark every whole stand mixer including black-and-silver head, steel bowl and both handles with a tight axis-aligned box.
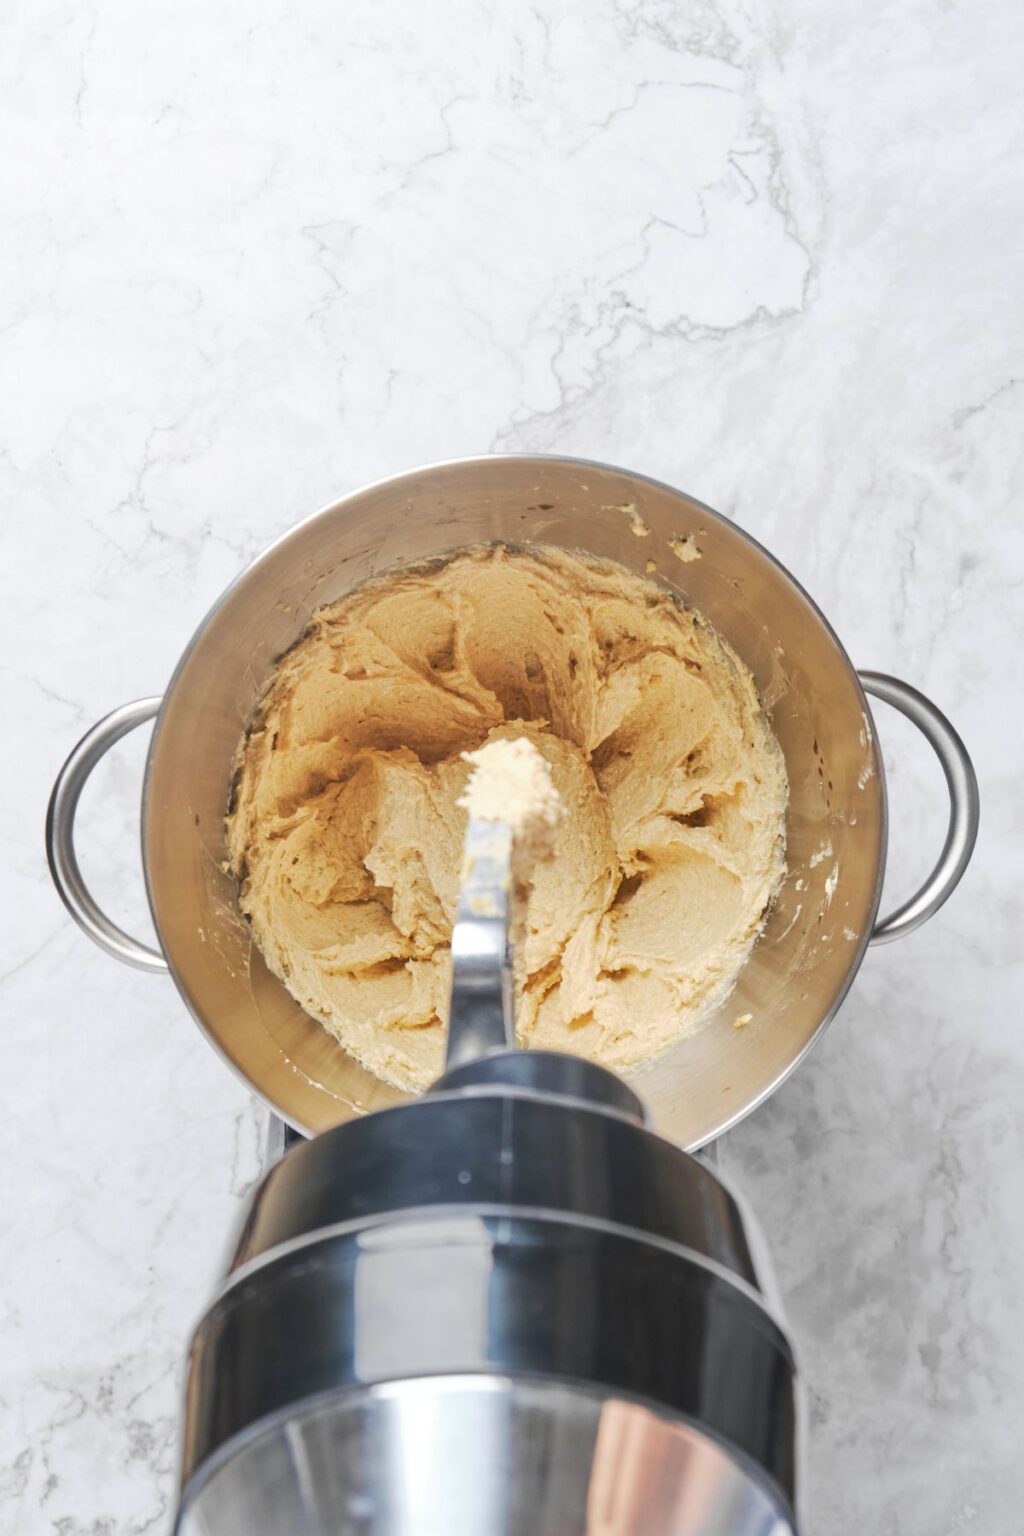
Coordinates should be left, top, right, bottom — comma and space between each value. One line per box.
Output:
46, 455, 978, 1536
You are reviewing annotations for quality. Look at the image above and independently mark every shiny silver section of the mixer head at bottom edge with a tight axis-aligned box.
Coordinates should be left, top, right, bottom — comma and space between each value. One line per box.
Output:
178, 1376, 792, 1536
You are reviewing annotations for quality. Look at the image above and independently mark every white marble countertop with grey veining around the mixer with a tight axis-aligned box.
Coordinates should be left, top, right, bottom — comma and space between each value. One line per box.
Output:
0, 0, 1024, 1536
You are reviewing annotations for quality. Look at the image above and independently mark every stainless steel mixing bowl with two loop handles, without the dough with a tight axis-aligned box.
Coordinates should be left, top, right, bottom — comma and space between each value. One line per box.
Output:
48, 458, 978, 1147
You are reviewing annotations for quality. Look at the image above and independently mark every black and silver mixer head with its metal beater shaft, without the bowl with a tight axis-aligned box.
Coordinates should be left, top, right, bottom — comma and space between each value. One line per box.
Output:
177, 749, 798, 1536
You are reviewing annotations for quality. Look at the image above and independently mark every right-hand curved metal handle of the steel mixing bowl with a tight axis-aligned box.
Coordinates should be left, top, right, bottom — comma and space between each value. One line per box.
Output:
858, 671, 979, 945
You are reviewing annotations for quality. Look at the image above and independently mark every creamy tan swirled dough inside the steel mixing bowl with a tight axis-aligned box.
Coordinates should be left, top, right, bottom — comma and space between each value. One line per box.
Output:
227, 545, 786, 1089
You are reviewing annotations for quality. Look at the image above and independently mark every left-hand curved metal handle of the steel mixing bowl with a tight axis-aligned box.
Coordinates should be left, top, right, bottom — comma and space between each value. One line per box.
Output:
46, 699, 169, 974
